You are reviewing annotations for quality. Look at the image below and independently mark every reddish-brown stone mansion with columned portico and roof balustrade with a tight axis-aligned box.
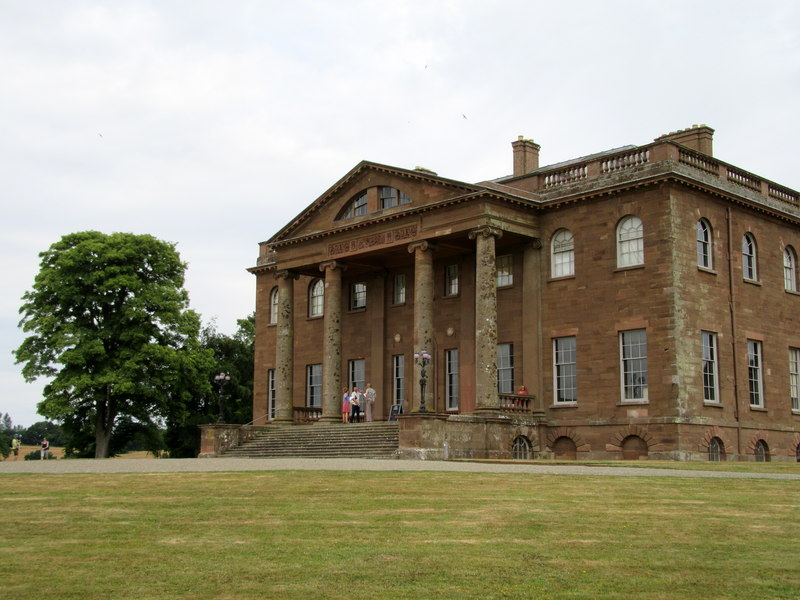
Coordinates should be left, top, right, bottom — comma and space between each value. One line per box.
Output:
250, 125, 800, 461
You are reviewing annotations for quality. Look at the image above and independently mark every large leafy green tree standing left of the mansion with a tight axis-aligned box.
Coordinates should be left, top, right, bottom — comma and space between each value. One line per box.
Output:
16, 231, 213, 458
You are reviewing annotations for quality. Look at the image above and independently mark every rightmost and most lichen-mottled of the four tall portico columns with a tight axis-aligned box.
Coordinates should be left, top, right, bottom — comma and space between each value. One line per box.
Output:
469, 227, 503, 412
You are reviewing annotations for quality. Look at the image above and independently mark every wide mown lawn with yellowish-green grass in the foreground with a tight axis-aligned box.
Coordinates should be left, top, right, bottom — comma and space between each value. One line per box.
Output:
0, 471, 800, 600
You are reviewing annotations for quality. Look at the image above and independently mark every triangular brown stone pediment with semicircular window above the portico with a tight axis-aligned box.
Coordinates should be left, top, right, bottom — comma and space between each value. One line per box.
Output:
267, 161, 485, 244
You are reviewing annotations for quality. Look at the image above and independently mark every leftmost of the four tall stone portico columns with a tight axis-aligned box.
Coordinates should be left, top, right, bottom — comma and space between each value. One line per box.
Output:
275, 270, 297, 424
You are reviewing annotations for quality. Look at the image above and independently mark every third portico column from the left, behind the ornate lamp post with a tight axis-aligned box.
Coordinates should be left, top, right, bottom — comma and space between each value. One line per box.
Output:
408, 241, 436, 412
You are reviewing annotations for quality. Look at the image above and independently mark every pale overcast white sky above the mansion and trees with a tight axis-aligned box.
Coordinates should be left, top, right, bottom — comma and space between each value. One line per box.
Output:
0, 0, 800, 426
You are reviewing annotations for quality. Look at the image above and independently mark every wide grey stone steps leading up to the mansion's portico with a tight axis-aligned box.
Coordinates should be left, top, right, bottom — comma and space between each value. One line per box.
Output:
223, 421, 400, 458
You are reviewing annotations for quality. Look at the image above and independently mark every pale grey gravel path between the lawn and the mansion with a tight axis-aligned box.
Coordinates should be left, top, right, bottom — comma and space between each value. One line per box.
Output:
0, 458, 800, 481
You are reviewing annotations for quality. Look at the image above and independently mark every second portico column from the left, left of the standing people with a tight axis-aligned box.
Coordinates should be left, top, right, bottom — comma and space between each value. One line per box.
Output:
319, 260, 344, 421
